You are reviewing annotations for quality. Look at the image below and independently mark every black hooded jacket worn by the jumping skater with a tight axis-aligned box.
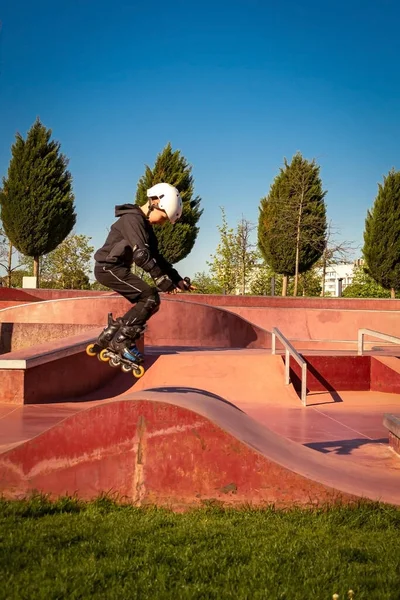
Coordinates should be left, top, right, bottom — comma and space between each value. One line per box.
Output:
94, 204, 182, 284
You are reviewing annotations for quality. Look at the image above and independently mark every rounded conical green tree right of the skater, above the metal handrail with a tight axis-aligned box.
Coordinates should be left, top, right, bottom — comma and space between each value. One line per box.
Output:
258, 152, 327, 296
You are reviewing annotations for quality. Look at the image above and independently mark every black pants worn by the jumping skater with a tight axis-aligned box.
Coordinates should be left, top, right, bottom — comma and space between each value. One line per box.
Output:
94, 263, 160, 327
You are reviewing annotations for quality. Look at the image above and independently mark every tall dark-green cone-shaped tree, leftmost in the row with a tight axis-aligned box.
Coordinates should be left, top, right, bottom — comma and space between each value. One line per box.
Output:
0, 119, 76, 286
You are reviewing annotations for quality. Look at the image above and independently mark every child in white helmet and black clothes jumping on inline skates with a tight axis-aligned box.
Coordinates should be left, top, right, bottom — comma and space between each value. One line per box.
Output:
94, 183, 194, 365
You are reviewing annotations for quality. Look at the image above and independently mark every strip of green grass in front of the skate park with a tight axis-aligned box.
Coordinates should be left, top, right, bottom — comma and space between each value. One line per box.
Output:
0, 496, 400, 600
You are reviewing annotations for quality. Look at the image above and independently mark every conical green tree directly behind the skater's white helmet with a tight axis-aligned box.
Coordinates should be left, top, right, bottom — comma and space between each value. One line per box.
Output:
136, 144, 203, 263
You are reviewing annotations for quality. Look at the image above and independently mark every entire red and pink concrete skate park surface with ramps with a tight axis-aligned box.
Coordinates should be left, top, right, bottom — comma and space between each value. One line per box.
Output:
0, 290, 400, 509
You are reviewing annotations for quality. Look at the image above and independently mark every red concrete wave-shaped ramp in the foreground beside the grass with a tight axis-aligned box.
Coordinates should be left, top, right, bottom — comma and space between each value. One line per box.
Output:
0, 388, 400, 508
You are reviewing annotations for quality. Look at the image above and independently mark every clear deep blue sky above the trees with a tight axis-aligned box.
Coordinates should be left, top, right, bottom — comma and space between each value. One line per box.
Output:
0, 0, 400, 276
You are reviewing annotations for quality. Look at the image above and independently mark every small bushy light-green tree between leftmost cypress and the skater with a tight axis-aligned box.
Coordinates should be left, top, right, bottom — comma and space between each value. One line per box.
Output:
41, 234, 94, 289
